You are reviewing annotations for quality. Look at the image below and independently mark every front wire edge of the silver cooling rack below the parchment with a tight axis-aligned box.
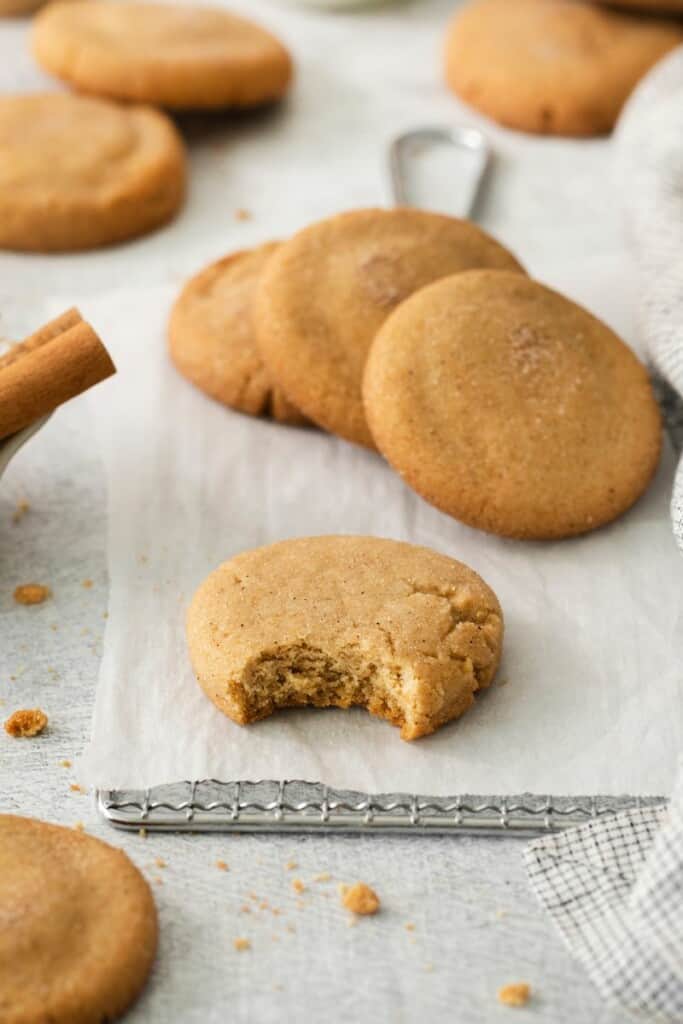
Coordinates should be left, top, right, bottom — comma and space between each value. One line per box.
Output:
97, 779, 665, 836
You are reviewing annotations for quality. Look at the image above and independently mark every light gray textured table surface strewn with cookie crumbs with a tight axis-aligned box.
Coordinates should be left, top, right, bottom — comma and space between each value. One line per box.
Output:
0, 0, 655, 1024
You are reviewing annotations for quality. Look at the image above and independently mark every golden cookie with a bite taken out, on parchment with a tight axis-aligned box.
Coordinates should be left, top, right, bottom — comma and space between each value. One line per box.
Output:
187, 537, 503, 739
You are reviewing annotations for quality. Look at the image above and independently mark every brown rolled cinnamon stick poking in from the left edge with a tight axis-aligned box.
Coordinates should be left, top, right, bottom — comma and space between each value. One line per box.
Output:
0, 309, 116, 440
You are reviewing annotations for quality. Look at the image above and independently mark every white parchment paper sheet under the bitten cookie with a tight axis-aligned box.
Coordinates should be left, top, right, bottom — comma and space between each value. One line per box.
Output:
77, 272, 683, 795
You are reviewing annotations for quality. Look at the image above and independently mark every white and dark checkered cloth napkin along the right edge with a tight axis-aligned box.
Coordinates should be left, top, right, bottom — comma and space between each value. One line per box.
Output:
524, 47, 683, 1024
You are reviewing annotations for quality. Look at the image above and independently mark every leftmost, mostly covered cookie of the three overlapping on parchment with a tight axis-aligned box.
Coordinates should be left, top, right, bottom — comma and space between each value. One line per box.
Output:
169, 242, 305, 424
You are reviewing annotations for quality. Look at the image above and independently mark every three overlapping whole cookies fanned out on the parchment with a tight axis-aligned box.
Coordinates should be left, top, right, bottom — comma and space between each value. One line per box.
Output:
169, 209, 660, 540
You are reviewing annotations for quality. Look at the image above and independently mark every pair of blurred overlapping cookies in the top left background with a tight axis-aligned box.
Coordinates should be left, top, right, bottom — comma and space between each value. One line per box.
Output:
0, 0, 292, 252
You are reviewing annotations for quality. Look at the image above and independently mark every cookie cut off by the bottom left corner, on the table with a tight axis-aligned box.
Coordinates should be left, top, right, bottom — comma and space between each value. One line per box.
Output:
0, 814, 157, 1024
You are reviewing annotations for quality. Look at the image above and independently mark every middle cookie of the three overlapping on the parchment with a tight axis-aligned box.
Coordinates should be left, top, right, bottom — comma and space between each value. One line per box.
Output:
255, 209, 521, 447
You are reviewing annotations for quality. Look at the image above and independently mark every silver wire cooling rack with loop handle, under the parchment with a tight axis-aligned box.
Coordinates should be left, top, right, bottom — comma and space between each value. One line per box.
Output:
96, 142, 683, 837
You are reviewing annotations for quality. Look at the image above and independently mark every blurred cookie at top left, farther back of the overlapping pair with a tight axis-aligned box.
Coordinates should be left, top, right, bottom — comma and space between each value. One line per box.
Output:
33, 0, 292, 110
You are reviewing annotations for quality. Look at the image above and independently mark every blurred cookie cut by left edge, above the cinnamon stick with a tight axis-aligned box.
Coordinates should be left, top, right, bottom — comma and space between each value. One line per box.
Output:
0, 92, 185, 252
